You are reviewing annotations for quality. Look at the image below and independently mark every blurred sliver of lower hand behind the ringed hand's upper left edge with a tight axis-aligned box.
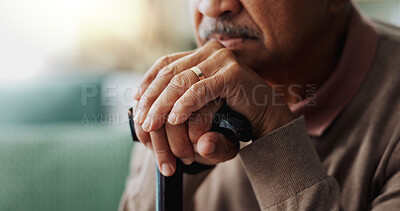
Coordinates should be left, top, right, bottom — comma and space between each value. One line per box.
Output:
133, 51, 193, 100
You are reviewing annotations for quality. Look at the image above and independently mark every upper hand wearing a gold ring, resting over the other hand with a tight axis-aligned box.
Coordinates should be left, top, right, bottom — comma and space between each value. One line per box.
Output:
135, 42, 293, 175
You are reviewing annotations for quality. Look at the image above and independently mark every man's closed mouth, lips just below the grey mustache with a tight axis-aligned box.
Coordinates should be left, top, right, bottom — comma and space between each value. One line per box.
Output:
209, 34, 257, 50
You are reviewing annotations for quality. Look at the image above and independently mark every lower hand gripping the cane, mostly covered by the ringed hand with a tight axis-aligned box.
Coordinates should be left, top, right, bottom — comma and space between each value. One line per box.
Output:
133, 48, 237, 176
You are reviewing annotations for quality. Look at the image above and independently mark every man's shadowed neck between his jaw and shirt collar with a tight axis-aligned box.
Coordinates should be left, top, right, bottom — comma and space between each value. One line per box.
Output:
260, 6, 349, 104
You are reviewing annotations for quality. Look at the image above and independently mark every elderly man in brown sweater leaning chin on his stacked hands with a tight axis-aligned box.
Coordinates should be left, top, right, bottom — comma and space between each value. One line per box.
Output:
120, 0, 400, 211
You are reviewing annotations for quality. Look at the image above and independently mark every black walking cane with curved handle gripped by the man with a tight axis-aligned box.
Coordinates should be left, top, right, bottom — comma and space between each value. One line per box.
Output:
129, 104, 253, 211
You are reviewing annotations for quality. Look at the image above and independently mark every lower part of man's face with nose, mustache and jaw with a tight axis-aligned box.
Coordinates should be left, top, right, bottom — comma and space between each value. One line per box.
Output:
190, 0, 329, 72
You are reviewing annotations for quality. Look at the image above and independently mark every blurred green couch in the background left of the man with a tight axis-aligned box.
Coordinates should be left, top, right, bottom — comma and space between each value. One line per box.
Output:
0, 73, 138, 211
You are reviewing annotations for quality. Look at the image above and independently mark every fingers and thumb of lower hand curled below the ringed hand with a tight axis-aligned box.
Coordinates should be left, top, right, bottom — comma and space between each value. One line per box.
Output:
135, 101, 238, 176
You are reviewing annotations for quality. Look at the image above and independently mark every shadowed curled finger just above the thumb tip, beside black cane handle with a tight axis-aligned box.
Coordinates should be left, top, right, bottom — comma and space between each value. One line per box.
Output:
187, 99, 223, 144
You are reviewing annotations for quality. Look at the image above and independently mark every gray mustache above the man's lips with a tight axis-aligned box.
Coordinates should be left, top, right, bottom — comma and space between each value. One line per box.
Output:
199, 21, 260, 40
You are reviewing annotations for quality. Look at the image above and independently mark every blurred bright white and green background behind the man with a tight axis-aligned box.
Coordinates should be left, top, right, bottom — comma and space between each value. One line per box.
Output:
0, 0, 400, 211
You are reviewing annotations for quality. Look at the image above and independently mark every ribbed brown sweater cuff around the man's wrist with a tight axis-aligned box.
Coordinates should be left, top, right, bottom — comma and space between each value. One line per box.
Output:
239, 117, 326, 209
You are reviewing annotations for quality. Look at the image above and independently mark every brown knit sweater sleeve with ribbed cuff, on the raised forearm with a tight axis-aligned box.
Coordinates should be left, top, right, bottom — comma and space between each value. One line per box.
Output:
239, 117, 340, 210
